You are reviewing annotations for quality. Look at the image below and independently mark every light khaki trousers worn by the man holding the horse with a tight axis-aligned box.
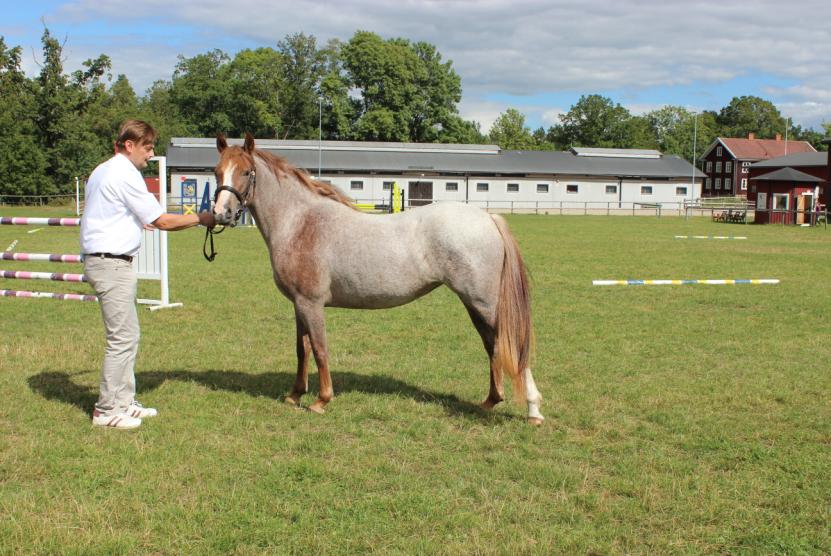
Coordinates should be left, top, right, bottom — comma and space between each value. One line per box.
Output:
84, 257, 141, 415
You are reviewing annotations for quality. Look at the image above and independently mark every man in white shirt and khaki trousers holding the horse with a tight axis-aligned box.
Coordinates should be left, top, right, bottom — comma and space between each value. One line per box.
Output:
81, 120, 216, 429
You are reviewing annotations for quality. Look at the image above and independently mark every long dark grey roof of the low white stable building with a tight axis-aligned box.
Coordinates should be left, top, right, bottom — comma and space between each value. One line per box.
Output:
167, 138, 704, 178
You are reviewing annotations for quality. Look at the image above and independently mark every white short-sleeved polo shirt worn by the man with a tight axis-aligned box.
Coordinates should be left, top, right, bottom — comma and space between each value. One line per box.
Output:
81, 154, 164, 255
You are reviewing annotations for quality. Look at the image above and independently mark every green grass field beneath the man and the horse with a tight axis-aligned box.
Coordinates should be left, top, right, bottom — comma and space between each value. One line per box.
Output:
0, 209, 831, 555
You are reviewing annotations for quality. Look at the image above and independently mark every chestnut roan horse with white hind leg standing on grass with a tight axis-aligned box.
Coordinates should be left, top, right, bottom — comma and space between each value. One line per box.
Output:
213, 133, 544, 425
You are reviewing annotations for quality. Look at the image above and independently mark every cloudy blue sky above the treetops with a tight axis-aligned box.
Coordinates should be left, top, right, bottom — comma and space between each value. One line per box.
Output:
6, 0, 831, 135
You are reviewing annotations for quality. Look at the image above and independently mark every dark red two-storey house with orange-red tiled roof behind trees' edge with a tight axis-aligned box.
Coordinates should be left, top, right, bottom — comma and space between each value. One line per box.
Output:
699, 133, 816, 197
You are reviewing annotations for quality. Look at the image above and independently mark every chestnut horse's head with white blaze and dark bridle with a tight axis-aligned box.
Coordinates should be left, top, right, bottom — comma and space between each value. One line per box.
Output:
214, 133, 256, 226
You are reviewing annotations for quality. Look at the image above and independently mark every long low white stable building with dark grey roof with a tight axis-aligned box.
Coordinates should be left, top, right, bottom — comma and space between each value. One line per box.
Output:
167, 138, 704, 212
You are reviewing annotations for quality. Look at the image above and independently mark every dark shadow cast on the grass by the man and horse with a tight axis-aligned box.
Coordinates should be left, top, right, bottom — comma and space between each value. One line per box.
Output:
28, 370, 511, 422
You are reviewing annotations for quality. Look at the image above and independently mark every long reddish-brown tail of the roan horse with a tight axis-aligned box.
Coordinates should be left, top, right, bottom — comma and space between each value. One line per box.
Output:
491, 214, 534, 404
